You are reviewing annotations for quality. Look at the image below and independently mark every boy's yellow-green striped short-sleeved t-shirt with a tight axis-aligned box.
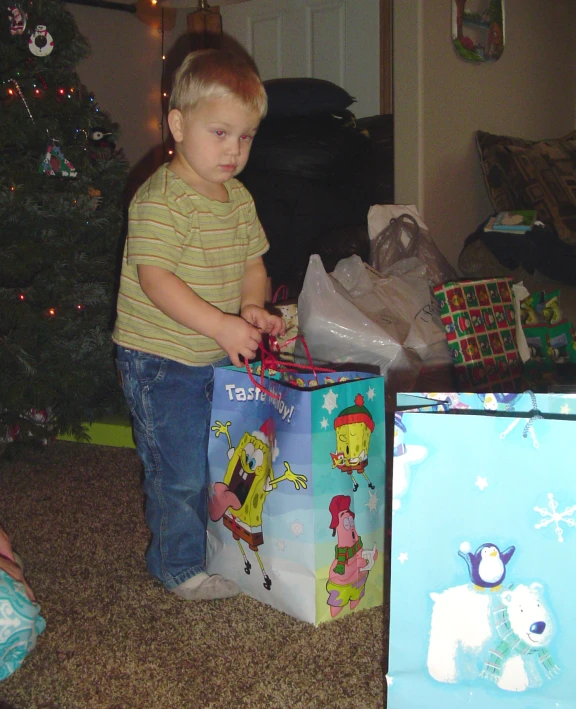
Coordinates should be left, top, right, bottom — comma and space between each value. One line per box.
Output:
112, 165, 268, 366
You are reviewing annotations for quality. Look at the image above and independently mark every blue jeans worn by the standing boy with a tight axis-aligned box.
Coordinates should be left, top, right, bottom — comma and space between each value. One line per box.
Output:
116, 345, 230, 589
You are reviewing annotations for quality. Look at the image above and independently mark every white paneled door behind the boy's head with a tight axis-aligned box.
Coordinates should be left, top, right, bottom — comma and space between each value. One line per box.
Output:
220, 0, 380, 118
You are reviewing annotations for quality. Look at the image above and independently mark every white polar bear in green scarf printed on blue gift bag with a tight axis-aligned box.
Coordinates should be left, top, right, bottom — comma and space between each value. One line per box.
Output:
427, 583, 559, 692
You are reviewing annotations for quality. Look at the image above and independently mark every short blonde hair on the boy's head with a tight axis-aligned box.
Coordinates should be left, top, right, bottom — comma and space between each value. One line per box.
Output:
168, 49, 268, 118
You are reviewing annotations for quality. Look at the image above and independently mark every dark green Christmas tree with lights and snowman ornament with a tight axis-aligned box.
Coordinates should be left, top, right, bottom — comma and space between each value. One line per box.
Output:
0, 0, 127, 441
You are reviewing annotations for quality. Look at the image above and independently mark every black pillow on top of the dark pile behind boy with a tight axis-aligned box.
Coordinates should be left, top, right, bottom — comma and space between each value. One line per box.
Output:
264, 77, 356, 116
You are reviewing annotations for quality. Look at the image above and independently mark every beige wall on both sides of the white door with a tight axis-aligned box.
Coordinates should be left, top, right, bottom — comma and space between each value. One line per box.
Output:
68, 0, 576, 264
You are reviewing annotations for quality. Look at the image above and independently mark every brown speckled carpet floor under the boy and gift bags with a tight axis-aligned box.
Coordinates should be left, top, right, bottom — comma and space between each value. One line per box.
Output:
0, 441, 386, 709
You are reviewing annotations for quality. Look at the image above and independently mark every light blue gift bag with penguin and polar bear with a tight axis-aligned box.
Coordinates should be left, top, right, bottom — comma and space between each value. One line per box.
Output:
387, 392, 576, 709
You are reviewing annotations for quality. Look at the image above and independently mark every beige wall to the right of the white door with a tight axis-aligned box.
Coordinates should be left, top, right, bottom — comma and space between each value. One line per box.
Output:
394, 0, 576, 264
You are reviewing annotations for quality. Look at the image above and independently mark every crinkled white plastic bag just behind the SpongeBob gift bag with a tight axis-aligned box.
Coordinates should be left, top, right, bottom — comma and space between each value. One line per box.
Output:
297, 255, 450, 391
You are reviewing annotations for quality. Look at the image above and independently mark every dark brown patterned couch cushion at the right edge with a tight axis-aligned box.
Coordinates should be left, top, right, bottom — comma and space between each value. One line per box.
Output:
476, 131, 576, 244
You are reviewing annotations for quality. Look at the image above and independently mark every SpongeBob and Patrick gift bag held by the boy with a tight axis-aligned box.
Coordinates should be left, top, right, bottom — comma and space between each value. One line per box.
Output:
207, 367, 385, 624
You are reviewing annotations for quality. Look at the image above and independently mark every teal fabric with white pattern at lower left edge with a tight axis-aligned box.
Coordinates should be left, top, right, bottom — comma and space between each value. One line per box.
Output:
0, 570, 46, 681
